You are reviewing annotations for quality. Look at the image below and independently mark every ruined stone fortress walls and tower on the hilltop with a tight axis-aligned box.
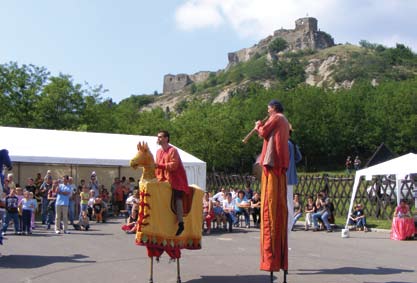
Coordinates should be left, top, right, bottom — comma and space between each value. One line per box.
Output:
163, 17, 334, 94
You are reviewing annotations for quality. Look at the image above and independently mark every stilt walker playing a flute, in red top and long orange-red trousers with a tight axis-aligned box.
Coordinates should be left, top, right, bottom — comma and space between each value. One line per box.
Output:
255, 100, 289, 277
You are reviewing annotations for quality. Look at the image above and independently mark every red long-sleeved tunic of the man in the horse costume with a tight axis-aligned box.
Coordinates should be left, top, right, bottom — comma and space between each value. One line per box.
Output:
155, 145, 190, 194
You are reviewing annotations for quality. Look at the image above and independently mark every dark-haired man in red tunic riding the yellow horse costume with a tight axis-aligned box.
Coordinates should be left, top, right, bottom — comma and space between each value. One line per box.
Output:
155, 131, 190, 236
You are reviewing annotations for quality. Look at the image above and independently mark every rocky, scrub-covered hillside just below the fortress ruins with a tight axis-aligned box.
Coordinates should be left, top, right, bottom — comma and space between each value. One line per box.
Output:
142, 41, 417, 112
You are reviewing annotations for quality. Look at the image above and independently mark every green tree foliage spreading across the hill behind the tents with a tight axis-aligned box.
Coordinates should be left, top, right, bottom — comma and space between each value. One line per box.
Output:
0, 48, 417, 172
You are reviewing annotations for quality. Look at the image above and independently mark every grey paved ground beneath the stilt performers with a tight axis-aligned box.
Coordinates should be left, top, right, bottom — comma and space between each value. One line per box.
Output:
0, 219, 417, 283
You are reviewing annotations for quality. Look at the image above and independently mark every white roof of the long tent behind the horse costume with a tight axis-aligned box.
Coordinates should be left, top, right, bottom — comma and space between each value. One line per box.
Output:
0, 127, 206, 189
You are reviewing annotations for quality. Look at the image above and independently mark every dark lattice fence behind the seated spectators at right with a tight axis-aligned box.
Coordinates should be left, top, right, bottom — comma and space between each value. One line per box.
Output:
207, 173, 417, 220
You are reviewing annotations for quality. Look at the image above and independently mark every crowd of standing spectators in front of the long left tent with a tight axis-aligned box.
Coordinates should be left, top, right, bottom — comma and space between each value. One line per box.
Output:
0, 170, 139, 235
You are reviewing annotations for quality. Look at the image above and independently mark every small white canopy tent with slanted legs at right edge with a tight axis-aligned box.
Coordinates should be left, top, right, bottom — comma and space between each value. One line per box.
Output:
345, 153, 417, 228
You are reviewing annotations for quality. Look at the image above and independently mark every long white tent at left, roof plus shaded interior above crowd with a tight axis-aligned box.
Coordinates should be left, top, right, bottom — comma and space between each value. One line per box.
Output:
0, 127, 206, 189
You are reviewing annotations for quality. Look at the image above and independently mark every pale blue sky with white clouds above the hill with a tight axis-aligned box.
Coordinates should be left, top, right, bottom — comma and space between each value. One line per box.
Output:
0, 0, 417, 102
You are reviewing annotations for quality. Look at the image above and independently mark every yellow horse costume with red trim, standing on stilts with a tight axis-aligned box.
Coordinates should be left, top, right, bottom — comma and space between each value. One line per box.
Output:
130, 143, 204, 283
